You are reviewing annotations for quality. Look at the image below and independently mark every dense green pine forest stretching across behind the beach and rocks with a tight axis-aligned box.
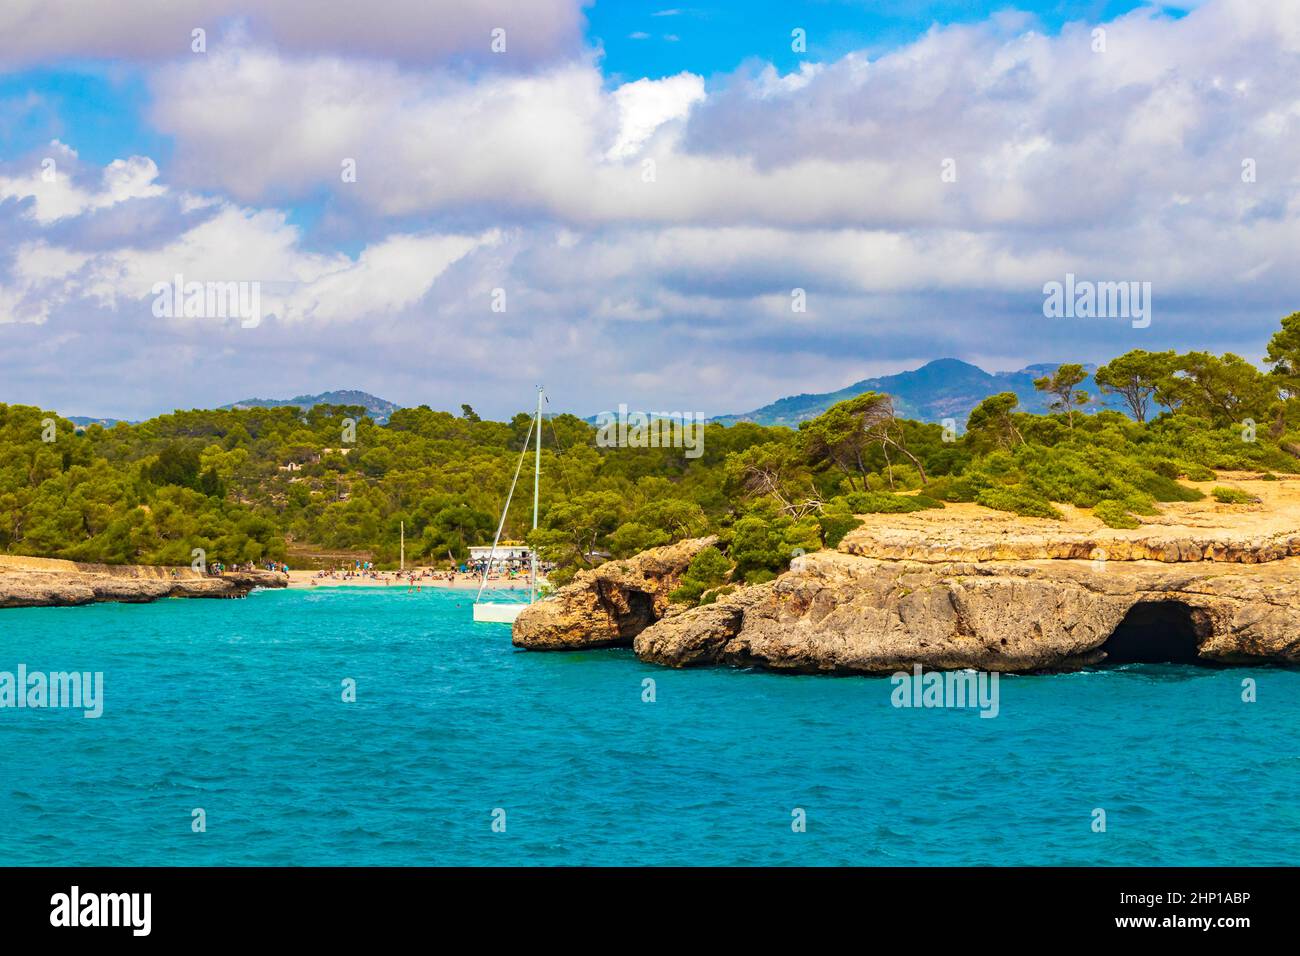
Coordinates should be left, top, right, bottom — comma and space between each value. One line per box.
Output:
0, 312, 1300, 600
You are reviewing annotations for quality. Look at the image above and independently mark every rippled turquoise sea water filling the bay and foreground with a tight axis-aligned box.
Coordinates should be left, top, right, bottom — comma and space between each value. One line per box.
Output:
0, 589, 1300, 865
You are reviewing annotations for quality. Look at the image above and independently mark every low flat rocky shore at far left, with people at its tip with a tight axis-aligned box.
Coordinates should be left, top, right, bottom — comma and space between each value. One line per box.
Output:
0, 555, 289, 607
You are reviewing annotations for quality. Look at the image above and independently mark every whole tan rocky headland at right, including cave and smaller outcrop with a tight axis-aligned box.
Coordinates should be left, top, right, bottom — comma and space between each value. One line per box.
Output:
514, 481, 1300, 674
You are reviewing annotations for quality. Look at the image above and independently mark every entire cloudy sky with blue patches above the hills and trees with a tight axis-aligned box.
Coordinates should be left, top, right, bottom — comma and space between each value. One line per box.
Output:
0, 0, 1300, 419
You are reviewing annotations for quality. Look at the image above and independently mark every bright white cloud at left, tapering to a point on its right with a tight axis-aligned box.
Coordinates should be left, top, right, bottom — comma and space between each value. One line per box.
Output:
0, 157, 499, 333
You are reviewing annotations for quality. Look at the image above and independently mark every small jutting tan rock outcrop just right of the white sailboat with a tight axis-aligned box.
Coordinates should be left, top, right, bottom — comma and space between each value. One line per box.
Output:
512, 537, 718, 650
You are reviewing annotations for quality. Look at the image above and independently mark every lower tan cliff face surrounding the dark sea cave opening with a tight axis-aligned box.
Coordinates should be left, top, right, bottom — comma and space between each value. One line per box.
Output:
634, 551, 1300, 674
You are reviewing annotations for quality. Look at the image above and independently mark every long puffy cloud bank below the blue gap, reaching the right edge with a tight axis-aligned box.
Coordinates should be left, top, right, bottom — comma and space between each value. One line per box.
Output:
139, 0, 1300, 243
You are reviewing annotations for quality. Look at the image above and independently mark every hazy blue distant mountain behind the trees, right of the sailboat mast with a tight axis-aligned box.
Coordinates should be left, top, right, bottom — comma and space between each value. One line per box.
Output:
710, 359, 1097, 429
